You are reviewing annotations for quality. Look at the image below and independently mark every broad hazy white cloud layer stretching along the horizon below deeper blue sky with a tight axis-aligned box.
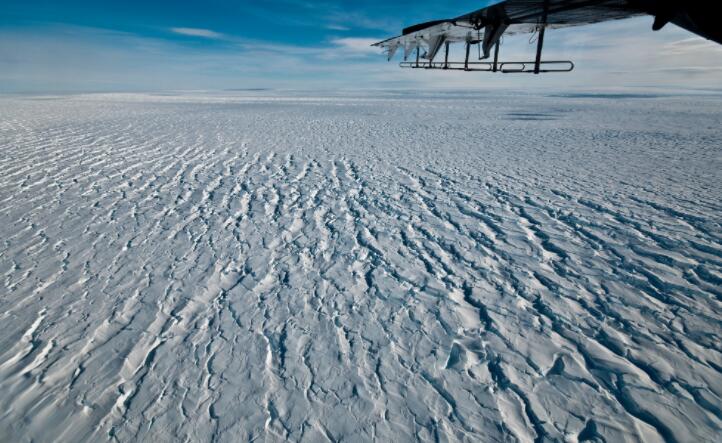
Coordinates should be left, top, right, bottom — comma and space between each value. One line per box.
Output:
0, 19, 722, 91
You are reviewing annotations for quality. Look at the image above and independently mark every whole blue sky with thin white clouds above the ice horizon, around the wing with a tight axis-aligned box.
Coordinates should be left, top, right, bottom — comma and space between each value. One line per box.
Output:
0, 0, 722, 93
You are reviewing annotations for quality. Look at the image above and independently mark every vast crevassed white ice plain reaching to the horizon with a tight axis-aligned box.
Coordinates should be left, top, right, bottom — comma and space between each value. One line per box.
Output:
0, 88, 722, 442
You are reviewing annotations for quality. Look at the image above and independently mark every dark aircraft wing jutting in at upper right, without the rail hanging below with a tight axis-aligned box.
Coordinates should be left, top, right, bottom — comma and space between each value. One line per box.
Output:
374, 0, 722, 67
